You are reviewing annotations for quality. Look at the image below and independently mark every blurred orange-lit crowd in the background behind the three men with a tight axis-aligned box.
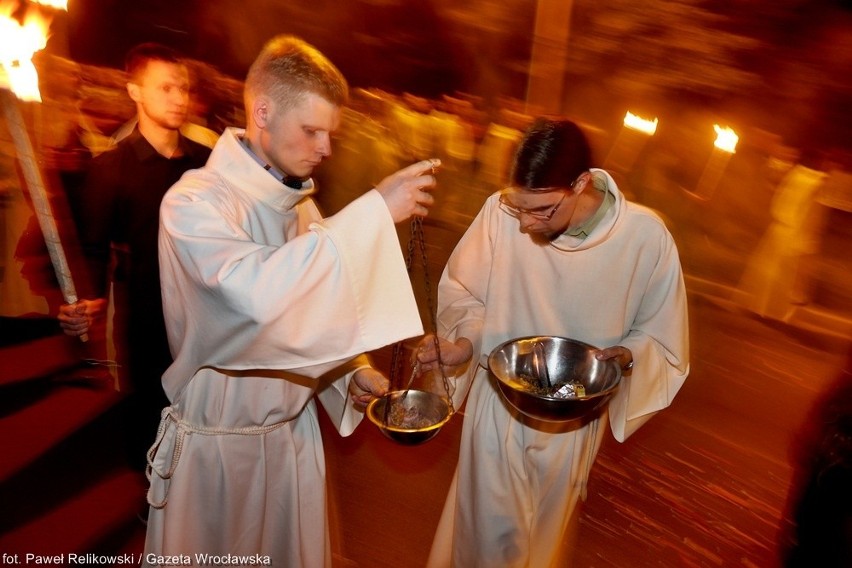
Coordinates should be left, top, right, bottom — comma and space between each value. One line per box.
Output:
0, 56, 852, 332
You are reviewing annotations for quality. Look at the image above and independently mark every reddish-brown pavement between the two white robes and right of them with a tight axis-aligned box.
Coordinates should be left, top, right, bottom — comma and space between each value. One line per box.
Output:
322, 286, 849, 568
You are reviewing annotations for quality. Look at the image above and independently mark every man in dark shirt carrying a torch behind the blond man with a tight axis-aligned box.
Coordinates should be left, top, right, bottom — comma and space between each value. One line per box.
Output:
59, 43, 210, 470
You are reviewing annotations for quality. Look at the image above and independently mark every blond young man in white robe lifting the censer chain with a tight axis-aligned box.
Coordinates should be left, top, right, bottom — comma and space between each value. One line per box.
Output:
143, 36, 438, 568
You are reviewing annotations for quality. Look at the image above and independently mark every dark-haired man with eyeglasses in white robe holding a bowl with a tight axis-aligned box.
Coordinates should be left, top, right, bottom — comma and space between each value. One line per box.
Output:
418, 119, 689, 567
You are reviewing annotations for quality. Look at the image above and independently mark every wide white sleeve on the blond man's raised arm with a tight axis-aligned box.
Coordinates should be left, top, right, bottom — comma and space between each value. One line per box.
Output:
160, 184, 423, 402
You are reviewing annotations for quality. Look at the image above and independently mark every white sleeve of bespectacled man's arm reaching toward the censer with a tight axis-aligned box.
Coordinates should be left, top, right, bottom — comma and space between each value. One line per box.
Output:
438, 203, 493, 408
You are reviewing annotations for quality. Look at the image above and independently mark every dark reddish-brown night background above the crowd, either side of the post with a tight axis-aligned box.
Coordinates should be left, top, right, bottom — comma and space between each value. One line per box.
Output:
49, 0, 852, 153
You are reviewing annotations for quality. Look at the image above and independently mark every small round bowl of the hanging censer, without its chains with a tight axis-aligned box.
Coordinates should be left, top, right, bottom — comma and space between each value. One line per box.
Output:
367, 390, 452, 445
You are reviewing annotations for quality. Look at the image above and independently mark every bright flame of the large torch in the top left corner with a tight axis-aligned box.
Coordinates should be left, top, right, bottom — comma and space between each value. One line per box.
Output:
0, 0, 65, 102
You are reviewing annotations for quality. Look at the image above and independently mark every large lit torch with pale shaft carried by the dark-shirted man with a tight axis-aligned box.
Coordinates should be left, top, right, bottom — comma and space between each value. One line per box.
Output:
0, 0, 88, 341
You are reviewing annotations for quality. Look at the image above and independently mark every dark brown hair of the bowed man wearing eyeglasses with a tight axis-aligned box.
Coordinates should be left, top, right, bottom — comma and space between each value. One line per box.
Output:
511, 118, 592, 189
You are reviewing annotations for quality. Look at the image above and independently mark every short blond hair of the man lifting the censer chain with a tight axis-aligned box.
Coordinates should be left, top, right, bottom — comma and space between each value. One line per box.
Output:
245, 35, 349, 112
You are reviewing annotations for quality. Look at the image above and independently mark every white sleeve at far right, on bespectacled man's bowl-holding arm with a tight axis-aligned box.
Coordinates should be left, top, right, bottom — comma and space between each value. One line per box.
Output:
609, 229, 689, 442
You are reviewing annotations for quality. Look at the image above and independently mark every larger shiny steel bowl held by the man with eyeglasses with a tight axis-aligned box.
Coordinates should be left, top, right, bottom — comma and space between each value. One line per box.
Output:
488, 336, 621, 422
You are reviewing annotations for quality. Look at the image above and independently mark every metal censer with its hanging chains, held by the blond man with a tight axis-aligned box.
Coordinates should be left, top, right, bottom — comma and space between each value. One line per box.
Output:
367, 217, 454, 445
